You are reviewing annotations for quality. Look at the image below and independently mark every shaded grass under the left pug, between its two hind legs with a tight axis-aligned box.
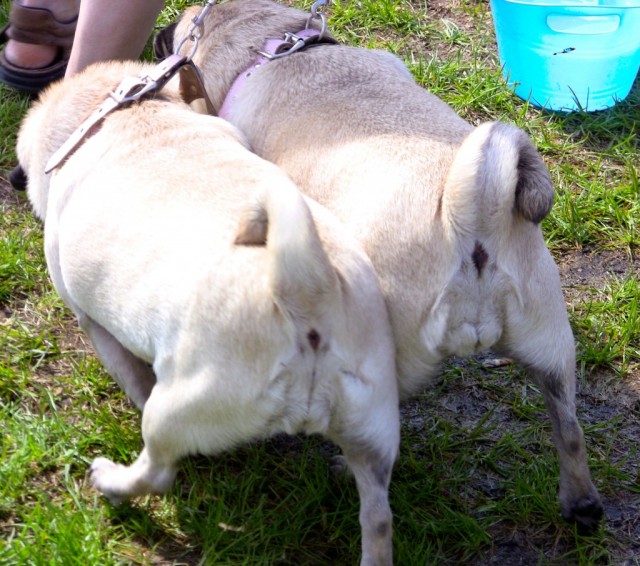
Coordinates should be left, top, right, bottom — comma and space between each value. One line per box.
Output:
101, 436, 360, 565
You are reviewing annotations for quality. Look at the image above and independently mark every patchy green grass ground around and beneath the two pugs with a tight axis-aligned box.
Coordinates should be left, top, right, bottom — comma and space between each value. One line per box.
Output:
0, 0, 640, 565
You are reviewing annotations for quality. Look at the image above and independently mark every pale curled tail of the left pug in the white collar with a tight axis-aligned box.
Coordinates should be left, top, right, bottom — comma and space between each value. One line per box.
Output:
236, 183, 339, 322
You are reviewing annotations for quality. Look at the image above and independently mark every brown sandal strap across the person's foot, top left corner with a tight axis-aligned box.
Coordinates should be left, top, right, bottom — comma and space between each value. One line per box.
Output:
6, 0, 78, 53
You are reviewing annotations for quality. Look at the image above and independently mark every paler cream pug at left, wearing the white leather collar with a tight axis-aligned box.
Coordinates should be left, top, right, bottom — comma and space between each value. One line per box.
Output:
17, 62, 400, 565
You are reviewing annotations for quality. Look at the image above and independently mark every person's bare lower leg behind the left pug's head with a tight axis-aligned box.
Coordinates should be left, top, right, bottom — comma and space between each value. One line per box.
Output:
66, 0, 164, 76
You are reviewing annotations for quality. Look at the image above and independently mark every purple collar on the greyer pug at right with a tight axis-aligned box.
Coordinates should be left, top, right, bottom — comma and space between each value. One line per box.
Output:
218, 28, 338, 119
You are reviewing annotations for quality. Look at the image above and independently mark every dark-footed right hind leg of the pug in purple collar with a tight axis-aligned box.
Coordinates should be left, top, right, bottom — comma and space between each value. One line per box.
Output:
501, 257, 603, 529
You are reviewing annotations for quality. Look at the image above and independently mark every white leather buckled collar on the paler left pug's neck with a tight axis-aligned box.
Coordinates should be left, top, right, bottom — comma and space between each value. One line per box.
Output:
44, 55, 213, 174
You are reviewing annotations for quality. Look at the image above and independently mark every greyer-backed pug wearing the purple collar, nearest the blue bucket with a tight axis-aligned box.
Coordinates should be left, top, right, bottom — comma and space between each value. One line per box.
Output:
155, 0, 603, 529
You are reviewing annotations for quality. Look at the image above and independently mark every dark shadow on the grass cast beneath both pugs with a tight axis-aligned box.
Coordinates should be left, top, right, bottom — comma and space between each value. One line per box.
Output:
92, 360, 637, 566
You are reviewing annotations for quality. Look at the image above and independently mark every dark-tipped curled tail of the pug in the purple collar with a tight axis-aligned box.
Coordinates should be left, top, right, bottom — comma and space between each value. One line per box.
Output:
442, 122, 554, 240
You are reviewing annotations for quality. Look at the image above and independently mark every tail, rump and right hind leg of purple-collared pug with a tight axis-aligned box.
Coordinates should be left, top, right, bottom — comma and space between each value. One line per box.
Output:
420, 123, 602, 528
